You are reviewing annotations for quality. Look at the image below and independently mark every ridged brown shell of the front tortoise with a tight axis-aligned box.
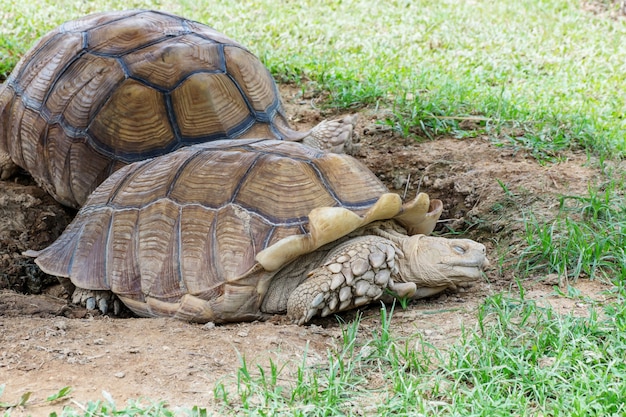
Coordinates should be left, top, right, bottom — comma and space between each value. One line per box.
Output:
29, 140, 440, 321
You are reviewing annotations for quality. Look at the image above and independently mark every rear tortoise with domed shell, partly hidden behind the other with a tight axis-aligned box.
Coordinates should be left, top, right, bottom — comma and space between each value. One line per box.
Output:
0, 10, 356, 208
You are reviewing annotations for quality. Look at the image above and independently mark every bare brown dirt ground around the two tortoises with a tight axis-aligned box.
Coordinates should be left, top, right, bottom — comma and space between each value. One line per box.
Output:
0, 87, 606, 416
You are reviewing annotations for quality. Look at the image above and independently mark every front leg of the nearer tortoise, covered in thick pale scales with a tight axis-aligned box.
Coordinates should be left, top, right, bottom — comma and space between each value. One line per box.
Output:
287, 236, 408, 324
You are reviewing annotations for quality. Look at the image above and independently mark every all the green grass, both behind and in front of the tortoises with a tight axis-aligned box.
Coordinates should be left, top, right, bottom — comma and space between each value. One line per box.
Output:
0, 0, 626, 416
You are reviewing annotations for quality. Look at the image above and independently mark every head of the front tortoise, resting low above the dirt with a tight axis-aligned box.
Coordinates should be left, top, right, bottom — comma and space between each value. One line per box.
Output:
398, 235, 489, 290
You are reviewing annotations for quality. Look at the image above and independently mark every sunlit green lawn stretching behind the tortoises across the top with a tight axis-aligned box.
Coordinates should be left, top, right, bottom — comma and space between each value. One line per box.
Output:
0, 0, 626, 158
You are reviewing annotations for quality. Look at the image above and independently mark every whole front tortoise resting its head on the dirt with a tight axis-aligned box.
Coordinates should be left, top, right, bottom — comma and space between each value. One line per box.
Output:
26, 139, 488, 324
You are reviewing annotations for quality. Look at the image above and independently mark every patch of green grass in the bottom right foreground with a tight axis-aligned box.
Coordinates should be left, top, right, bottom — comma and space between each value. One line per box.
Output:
213, 294, 626, 416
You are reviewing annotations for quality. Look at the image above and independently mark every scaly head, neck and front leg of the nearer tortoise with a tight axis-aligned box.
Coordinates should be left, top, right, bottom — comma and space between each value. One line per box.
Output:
287, 230, 489, 324
